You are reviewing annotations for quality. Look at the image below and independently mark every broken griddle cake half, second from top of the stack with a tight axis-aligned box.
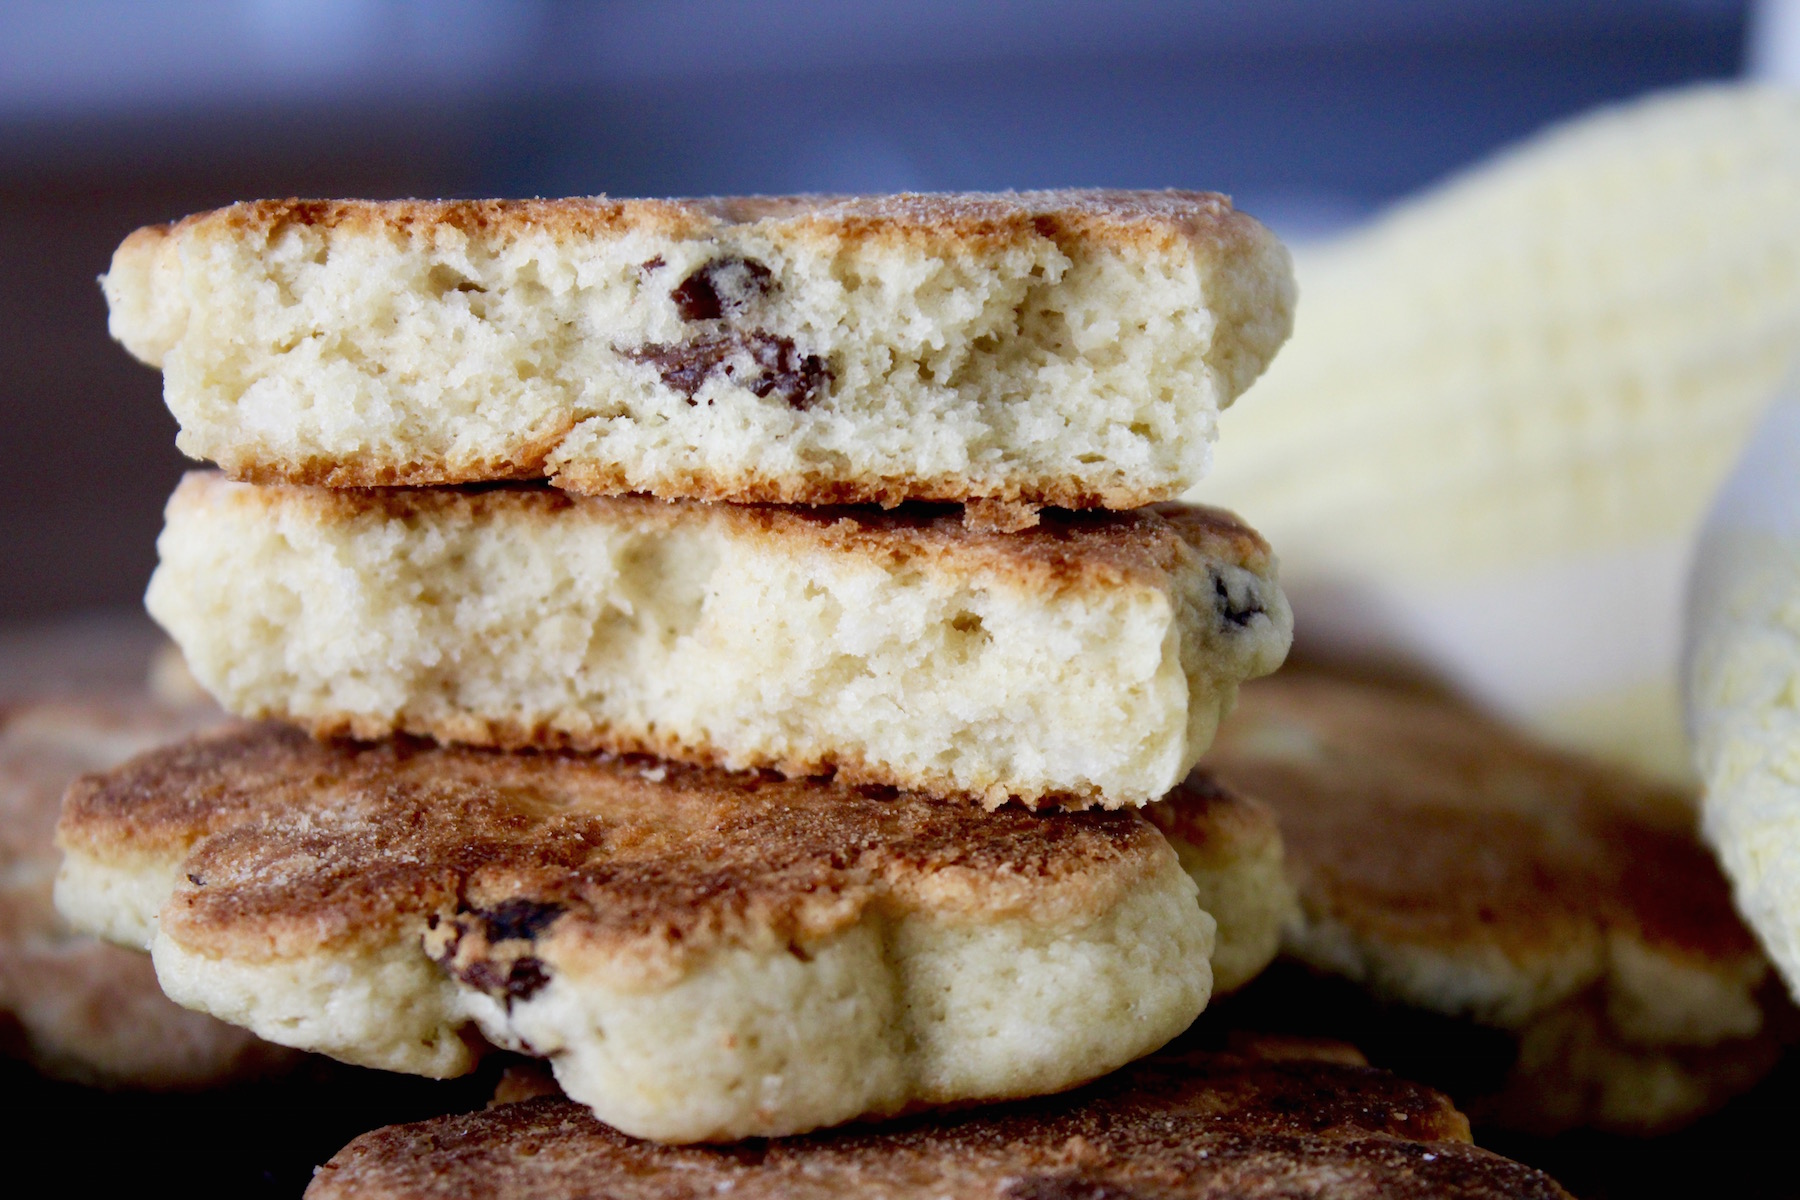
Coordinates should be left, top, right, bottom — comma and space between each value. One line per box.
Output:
148, 471, 1292, 808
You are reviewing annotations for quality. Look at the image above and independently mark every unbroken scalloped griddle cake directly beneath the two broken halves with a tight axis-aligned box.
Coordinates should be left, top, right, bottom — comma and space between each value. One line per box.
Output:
58, 725, 1265, 1141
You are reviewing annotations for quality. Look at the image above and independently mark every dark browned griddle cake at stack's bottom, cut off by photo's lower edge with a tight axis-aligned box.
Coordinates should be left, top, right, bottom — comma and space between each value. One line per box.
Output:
308, 1047, 1564, 1200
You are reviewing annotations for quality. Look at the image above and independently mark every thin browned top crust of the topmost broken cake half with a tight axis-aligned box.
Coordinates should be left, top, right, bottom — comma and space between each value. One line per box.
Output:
126, 189, 1260, 262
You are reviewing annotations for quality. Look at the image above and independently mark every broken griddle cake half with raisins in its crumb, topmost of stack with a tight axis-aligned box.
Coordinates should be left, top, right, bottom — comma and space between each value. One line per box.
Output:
103, 191, 1294, 507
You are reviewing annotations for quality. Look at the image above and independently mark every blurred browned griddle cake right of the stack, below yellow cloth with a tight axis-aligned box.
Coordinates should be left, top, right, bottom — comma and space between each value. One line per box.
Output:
1206, 673, 1778, 1132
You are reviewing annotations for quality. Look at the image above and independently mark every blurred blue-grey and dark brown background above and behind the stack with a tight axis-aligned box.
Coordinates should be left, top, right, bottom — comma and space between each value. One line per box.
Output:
0, 0, 1795, 619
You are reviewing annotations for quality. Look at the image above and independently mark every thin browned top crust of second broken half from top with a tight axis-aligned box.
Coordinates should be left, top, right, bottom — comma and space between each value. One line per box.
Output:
169, 471, 1274, 587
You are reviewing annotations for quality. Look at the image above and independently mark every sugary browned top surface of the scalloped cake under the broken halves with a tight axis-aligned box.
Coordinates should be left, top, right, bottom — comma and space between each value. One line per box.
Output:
58, 725, 1170, 972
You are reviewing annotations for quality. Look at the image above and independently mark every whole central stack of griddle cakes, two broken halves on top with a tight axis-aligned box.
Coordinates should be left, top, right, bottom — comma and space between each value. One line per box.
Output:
45, 193, 1620, 1196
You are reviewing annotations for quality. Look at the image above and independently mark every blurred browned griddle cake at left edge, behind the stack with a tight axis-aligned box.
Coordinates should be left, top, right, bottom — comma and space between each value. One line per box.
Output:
0, 694, 293, 1088
